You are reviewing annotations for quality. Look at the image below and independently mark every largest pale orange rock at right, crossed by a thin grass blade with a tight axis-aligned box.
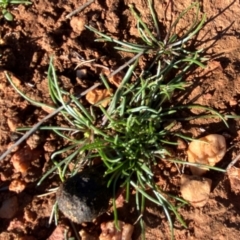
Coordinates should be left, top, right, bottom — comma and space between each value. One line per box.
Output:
187, 134, 226, 176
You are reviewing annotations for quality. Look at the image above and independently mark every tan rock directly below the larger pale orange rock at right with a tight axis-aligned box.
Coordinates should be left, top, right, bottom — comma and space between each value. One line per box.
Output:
180, 175, 212, 207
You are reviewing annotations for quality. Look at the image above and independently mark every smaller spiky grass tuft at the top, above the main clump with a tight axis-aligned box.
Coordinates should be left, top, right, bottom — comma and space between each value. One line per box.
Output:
86, 0, 206, 80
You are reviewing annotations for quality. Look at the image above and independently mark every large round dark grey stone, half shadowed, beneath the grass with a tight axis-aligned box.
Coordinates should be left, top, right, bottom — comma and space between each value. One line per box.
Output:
57, 170, 113, 223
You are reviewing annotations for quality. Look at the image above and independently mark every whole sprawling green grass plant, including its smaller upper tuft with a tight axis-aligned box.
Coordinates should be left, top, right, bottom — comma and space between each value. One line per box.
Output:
1, 0, 231, 237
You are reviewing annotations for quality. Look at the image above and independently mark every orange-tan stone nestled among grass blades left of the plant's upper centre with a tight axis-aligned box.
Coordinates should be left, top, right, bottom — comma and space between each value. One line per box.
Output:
86, 89, 112, 107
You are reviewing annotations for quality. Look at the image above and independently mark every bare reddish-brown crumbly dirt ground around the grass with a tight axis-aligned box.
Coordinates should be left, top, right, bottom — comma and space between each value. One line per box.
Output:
0, 0, 240, 240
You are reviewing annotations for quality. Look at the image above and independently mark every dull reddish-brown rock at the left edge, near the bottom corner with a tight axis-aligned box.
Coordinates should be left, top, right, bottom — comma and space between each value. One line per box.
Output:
0, 196, 18, 219
